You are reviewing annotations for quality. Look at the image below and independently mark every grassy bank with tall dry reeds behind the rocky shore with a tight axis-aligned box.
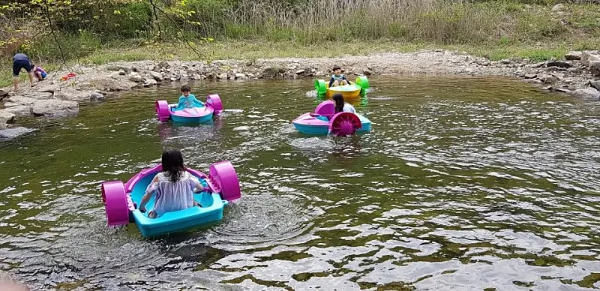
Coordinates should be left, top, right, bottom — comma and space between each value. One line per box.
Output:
0, 0, 600, 86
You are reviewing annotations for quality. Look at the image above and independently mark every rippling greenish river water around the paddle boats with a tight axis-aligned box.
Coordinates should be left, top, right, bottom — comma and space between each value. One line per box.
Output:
0, 77, 600, 290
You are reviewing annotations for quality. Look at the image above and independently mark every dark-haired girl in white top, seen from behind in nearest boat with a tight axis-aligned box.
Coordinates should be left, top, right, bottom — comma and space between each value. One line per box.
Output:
139, 149, 203, 218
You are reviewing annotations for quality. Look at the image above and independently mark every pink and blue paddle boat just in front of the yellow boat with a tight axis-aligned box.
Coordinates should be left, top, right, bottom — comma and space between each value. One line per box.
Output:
292, 100, 371, 136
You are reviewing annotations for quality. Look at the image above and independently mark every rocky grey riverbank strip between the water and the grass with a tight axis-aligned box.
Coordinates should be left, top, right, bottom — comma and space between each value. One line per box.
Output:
0, 50, 600, 139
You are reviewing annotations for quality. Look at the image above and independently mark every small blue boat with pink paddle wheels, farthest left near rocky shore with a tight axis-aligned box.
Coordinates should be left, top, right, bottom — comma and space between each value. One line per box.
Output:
155, 94, 223, 123
